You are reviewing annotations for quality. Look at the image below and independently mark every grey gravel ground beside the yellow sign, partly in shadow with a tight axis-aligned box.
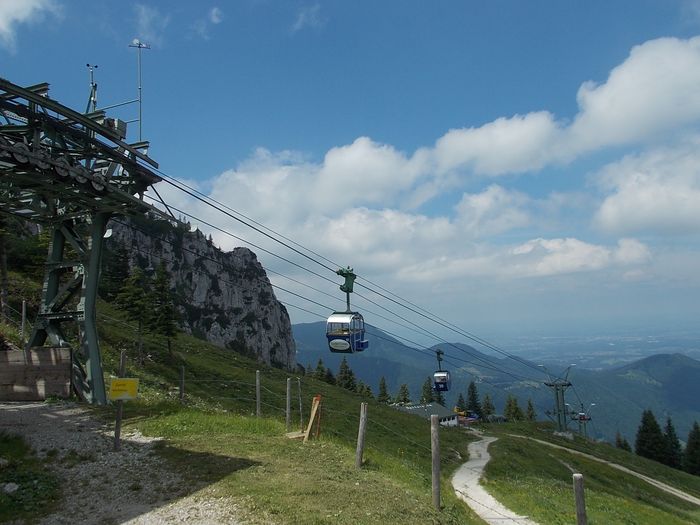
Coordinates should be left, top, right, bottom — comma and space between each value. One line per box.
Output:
0, 402, 242, 525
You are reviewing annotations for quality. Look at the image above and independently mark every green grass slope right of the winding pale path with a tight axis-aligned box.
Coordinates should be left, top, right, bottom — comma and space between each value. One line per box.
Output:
485, 424, 700, 525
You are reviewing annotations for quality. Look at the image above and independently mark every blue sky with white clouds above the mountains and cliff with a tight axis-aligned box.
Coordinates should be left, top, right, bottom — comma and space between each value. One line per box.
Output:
0, 0, 700, 341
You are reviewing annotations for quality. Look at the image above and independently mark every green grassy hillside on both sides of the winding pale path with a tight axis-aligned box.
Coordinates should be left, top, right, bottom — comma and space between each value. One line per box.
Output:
2, 292, 700, 524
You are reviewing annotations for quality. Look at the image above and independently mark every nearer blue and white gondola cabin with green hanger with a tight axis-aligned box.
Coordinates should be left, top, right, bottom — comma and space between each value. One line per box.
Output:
326, 266, 369, 354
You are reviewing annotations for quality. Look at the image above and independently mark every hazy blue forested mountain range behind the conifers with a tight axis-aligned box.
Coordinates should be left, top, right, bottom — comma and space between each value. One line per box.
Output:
292, 322, 700, 444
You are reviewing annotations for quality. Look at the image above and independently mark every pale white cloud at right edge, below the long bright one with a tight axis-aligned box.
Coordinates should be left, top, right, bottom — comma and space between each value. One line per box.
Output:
594, 139, 700, 235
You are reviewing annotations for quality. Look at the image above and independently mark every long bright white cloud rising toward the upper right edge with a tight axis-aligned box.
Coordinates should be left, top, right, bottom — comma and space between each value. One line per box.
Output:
428, 37, 700, 176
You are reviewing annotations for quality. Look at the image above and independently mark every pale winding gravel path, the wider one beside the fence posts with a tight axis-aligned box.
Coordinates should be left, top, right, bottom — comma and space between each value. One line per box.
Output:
452, 432, 537, 525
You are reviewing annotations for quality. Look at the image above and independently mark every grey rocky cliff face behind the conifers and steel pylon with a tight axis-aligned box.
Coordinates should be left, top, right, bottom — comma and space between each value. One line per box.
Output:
105, 219, 296, 370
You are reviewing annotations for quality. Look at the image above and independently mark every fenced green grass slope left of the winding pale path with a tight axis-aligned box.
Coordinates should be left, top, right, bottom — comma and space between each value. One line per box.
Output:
95, 305, 482, 524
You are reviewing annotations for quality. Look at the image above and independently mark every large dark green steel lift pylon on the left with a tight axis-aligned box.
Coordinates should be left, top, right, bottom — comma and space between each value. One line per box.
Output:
0, 78, 173, 404
